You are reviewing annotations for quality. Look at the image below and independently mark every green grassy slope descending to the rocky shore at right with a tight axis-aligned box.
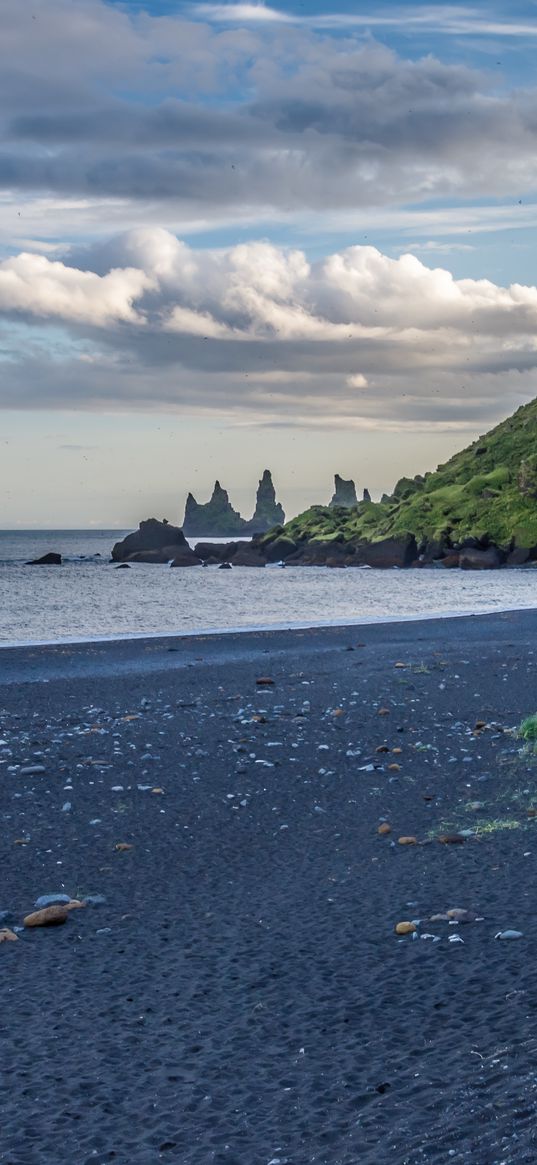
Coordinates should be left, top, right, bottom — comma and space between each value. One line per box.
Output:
256, 400, 537, 558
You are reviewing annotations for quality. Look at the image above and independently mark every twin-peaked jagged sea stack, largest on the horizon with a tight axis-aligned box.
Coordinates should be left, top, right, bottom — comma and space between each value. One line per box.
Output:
183, 469, 285, 538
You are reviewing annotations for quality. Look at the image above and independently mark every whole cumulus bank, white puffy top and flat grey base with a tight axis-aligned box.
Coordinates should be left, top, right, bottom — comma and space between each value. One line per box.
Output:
0, 228, 537, 429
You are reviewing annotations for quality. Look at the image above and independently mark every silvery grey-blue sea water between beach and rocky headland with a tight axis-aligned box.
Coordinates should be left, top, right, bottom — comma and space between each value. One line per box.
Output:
0, 530, 537, 644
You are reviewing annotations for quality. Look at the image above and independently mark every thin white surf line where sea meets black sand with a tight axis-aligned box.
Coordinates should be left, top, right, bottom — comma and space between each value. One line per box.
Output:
0, 603, 537, 652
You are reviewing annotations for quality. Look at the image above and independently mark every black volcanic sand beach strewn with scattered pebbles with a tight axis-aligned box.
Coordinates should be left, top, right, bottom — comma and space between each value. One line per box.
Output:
0, 612, 537, 1165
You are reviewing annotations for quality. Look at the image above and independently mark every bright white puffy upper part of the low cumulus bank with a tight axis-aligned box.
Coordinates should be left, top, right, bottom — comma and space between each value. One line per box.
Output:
6, 227, 537, 340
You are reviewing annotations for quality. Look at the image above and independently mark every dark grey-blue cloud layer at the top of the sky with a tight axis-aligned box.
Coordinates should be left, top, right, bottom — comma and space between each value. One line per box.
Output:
0, 0, 537, 241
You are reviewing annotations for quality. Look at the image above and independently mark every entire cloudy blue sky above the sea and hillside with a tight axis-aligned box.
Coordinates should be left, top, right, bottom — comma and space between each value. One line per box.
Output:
0, 0, 537, 528
